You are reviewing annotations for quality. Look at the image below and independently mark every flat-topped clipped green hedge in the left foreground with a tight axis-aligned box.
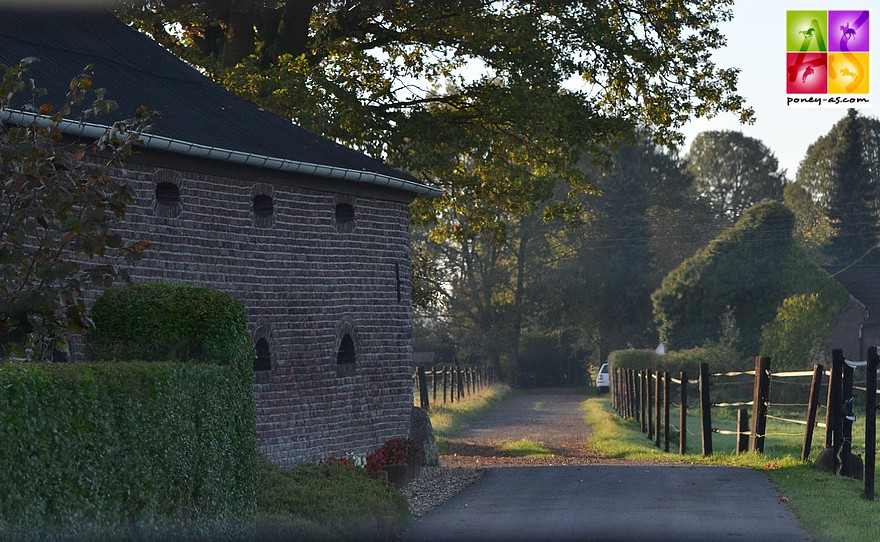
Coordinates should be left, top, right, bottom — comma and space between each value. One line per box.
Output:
0, 362, 256, 539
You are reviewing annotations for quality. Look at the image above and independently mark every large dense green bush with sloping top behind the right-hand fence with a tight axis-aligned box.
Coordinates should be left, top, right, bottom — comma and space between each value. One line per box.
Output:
652, 202, 842, 354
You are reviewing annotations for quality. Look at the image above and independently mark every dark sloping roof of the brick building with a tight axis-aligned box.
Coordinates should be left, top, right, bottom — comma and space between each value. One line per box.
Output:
0, 10, 438, 195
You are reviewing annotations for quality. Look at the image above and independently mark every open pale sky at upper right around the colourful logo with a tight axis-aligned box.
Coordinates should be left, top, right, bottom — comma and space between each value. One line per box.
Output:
683, 0, 880, 180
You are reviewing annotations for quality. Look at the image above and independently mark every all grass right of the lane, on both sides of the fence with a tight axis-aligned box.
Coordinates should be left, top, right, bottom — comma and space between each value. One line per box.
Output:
582, 398, 880, 542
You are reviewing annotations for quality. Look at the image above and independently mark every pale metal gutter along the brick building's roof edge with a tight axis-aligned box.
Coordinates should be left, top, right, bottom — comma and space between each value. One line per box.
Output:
0, 109, 443, 197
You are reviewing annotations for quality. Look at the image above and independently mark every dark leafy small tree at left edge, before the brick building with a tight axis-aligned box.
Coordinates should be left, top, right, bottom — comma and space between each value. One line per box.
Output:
0, 58, 151, 360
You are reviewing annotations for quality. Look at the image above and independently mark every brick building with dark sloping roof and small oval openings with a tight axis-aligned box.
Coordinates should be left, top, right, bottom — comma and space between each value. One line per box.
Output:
0, 8, 437, 465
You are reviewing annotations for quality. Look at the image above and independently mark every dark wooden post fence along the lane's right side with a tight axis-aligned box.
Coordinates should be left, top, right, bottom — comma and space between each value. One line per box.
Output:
611, 347, 878, 500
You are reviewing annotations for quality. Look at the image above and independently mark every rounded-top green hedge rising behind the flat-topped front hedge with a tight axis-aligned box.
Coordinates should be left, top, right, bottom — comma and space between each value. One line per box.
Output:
86, 282, 254, 374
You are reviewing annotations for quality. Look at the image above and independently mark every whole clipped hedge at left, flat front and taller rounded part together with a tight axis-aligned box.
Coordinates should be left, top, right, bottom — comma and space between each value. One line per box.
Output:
0, 284, 256, 539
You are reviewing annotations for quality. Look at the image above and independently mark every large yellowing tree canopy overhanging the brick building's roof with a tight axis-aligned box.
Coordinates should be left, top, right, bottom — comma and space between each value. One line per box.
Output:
120, 0, 752, 239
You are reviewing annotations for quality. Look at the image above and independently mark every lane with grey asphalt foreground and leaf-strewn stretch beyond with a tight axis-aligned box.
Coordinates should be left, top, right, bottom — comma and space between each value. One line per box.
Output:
401, 391, 810, 542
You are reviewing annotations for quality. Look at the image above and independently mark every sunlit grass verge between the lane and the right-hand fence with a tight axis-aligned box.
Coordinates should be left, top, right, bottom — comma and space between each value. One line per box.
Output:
582, 398, 880, 542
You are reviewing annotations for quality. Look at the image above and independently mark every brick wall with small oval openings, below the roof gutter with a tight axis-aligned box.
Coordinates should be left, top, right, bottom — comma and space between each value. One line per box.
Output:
95, 155, 412, 465
